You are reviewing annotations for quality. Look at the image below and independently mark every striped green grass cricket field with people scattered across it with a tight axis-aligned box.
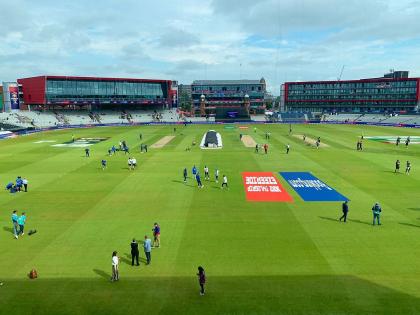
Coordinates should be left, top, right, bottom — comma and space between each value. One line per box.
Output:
0, 125, 420, 315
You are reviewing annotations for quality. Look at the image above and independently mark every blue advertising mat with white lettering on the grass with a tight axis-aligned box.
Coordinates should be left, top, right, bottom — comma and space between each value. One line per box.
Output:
280, 172, 348, 201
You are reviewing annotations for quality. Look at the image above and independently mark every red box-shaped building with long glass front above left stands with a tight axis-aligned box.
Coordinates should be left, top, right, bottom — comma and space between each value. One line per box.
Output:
18, 76, 172, 108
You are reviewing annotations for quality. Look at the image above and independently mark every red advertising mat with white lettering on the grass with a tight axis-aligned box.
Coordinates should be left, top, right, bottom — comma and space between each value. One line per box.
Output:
242, 172, 293, 202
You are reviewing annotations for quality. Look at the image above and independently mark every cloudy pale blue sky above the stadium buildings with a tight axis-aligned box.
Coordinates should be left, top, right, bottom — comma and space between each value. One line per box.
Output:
0, 0, 420, 94
